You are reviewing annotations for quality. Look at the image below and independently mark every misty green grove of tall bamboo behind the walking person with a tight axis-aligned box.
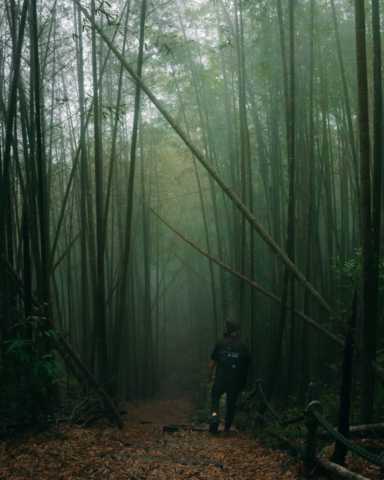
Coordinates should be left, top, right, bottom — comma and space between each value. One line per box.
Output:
0, 0, 384, 423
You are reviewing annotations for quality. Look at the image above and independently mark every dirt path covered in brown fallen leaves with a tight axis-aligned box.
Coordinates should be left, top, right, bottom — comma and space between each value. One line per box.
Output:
0, 389, 380, 480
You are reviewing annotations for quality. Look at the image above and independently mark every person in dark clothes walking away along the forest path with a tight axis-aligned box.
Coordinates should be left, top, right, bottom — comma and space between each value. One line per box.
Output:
208, 318, 250, 432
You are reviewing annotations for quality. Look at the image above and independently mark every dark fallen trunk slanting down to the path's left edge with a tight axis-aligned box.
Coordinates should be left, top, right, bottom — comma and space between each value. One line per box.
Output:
3, 254, 123, 428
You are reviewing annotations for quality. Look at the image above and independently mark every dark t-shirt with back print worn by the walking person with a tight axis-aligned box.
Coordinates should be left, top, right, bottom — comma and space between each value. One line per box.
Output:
211, 339, 250, 389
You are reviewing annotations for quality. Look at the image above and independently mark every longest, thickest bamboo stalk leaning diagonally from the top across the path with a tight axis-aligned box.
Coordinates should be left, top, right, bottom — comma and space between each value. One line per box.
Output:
73, 0, 340, 323
